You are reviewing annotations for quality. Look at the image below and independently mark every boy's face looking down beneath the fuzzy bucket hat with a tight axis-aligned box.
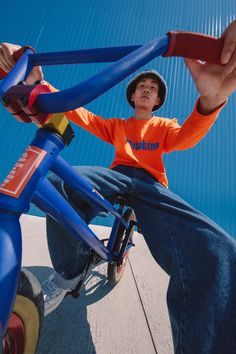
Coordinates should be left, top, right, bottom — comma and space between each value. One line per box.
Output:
131, 78, 160, 112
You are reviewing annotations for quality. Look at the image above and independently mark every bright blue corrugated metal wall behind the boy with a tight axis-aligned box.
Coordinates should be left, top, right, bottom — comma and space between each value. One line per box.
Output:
0, 0, 236, 237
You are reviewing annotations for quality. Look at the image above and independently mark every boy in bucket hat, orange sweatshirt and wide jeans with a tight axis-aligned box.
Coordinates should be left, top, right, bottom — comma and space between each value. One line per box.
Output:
31, 68, 236, 353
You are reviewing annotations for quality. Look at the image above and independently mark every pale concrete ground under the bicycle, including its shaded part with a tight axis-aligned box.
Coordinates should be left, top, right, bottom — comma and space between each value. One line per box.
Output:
21, 215, 173, 354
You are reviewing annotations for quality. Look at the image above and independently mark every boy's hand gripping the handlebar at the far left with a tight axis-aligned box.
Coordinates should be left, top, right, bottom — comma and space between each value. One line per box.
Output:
0, 43, 43, 84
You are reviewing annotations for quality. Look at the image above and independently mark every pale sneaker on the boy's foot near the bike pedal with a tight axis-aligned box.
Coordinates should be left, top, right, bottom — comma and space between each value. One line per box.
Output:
41, 272, 82, 316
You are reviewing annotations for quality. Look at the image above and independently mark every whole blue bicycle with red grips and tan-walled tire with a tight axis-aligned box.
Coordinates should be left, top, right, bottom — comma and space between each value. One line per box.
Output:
0, 32, 223, 354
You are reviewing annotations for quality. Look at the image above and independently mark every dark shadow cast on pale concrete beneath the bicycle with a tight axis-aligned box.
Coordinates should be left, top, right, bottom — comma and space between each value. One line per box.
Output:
27, 264, 113, 354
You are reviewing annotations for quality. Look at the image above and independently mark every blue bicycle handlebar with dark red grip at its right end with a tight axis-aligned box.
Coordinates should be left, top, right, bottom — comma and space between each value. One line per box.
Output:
0, 32, 224, 113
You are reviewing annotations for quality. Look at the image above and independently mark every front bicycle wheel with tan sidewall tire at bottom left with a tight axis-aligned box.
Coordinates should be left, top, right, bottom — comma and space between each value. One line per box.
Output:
3, 268, 44, 354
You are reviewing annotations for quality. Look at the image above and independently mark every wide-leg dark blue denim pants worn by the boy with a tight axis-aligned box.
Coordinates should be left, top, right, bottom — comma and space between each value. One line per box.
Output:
47, 165, 236, 354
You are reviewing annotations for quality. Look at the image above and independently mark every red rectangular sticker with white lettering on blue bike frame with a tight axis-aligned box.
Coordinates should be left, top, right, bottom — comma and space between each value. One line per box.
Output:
0, 145, 47, 198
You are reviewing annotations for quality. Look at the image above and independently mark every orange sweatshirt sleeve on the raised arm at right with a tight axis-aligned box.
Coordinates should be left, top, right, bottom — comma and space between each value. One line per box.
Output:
164, 100, 225, 152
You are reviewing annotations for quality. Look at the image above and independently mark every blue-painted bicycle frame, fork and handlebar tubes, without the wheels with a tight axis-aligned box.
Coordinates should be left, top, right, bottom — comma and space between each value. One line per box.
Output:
0, 33, 223, 338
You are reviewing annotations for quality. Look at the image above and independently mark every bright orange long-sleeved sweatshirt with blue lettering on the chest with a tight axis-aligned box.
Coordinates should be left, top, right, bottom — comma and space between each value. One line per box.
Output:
65, 99, 223, 187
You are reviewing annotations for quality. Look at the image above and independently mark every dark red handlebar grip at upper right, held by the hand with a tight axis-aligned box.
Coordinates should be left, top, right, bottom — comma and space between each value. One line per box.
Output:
163, 32, 224, 65
